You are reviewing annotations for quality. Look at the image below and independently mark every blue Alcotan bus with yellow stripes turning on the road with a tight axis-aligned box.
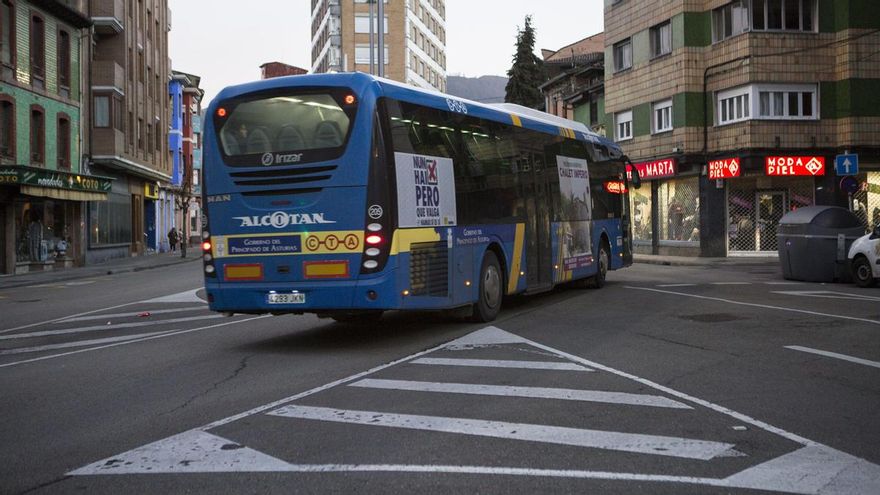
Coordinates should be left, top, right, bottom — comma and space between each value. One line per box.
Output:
202, 73, 638, 321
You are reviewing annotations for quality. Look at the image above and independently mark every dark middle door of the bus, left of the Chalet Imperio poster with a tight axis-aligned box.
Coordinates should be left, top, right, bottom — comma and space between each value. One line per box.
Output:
520, 153, 553, 291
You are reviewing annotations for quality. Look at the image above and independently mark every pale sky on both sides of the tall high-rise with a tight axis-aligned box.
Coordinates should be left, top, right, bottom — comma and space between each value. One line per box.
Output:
168, 0, 603, 106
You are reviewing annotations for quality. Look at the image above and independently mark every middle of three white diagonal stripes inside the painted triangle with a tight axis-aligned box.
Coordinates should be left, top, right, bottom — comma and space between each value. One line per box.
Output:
349, 378, 693, 409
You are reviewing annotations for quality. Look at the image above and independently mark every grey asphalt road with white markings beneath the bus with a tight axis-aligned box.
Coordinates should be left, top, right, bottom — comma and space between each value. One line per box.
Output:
0, 263, 880, 494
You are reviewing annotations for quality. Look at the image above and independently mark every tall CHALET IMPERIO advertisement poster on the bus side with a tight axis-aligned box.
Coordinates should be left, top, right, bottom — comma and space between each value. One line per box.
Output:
556, 156, 593, 271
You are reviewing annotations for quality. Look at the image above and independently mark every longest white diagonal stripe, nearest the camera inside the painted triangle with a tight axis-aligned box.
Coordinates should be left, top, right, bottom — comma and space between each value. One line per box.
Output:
268, 405, 734, 461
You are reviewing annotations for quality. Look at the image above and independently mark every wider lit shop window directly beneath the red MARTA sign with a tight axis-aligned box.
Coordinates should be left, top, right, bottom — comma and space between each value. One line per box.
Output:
657, 177, 700, 242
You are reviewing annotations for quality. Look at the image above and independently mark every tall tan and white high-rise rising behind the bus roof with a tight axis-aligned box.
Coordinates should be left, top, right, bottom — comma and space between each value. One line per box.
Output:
311, 0, 446, 91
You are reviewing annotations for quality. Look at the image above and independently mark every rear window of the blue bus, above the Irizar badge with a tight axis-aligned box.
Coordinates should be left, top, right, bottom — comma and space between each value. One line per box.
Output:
215, 92, 356, 165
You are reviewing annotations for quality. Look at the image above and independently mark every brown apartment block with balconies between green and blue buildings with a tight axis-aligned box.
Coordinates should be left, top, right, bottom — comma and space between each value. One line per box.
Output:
87, 0, 172, 263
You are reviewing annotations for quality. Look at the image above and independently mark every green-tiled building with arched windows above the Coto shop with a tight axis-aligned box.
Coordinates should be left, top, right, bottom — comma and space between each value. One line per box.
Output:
0, 0, 111, 274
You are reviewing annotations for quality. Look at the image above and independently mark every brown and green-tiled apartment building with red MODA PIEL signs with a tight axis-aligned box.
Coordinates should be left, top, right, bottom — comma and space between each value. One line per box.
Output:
605, 0, 880, 256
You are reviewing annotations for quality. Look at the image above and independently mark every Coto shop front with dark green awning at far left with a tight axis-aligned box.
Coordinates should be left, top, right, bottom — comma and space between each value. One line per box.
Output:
0, 165, 111, 274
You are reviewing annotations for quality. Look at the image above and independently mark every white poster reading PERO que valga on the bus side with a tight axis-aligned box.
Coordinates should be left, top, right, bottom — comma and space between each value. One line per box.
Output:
394, 153, 456, 227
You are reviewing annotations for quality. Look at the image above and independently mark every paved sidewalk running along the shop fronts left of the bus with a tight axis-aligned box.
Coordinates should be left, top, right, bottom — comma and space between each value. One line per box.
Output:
0, 252, 202, 290
